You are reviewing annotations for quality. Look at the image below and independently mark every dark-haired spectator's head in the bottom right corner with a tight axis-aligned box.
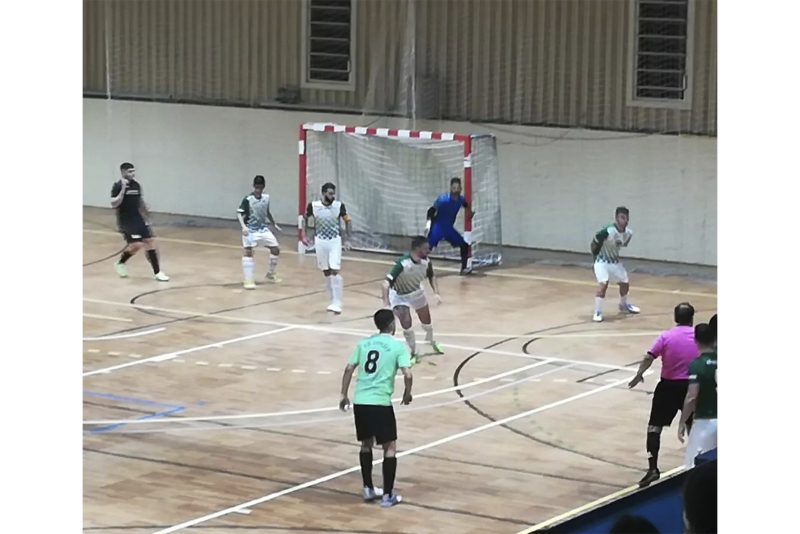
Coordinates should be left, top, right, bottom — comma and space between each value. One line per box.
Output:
683, 460, 717, 534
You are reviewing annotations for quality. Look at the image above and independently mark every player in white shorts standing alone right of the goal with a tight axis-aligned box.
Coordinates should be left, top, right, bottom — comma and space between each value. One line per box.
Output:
591, 207, 640, 323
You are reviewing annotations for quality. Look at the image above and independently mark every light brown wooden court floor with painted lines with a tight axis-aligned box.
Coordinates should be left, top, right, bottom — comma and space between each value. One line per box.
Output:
83, 209, 716, 534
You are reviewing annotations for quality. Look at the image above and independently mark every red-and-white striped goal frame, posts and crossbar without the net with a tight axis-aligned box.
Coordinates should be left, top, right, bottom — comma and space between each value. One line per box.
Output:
297, 123, 500, 266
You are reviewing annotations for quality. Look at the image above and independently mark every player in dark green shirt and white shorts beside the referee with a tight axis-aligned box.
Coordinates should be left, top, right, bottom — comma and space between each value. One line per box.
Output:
678, 323, 717, 469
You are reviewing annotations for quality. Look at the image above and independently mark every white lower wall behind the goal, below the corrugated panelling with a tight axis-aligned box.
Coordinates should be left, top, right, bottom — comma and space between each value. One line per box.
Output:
83, 99, 717, 265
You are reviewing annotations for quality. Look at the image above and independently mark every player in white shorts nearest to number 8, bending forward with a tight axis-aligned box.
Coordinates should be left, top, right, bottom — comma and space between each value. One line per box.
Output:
383, 236, 443, 363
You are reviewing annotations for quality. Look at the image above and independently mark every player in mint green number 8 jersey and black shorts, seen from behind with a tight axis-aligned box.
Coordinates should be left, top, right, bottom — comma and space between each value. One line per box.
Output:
339, 309, 413, 507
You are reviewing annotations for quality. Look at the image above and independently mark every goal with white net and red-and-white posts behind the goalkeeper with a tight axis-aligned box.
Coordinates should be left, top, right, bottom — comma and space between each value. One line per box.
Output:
298, 123, 502, 267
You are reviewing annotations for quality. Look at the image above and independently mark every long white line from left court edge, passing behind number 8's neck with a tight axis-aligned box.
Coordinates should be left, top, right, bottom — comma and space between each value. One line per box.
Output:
83, 297, 648, 370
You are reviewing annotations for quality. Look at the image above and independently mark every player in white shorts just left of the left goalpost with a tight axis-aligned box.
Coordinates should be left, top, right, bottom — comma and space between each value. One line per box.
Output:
236, 174, 281, 289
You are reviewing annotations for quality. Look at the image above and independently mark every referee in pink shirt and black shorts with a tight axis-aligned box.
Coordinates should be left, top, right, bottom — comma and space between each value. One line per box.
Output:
628, 302, 700, 488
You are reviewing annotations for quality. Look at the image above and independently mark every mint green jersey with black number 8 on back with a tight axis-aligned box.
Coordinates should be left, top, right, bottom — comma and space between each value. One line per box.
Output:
350, 334, 411, 406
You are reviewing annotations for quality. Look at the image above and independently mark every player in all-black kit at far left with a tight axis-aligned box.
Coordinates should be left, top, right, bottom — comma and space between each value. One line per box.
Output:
111, 163, 169, 282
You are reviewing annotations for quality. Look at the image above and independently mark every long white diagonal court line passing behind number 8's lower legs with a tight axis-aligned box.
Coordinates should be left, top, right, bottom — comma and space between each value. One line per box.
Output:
154, 378, 628, 534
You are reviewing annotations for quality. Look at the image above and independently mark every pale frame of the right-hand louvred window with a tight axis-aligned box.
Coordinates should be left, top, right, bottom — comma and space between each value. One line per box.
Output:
625, 0, 697, 110
